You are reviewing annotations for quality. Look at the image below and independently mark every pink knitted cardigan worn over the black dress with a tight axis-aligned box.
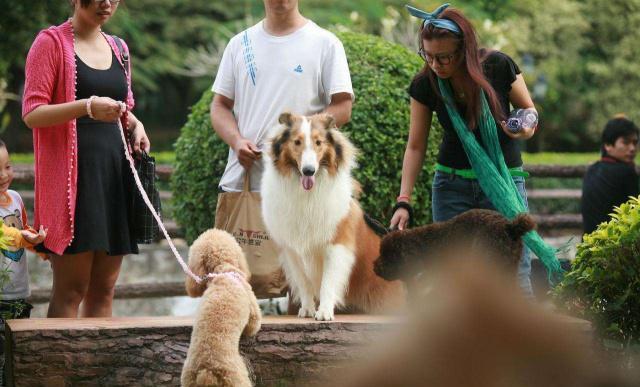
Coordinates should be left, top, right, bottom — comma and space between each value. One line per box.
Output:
22, 20, 134, 255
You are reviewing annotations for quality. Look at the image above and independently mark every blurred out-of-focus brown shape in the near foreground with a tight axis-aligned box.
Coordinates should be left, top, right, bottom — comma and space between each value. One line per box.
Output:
331, 257, 640, 387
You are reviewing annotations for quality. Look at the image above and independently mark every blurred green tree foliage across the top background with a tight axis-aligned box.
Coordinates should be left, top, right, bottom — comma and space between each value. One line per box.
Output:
0, 0, 640, 151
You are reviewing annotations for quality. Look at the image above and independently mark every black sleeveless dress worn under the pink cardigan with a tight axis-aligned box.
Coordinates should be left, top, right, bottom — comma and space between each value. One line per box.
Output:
65, 52, 138, 255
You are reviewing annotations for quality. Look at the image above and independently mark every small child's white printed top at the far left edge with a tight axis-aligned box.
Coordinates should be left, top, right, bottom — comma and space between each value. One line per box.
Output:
0, 190, 30, 300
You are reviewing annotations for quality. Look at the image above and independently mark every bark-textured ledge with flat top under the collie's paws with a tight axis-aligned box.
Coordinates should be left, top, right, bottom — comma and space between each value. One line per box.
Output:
5, 315, 401, 386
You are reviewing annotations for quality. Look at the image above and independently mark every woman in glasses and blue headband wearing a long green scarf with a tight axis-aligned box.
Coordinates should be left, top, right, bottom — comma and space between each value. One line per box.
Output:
391, 4, 557, 296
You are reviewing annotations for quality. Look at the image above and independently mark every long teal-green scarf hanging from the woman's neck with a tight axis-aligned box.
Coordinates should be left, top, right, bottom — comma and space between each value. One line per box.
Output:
438, 78, 562, 282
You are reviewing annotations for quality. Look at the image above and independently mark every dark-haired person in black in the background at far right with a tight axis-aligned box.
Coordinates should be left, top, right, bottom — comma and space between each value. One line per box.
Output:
581, 116, 640, 234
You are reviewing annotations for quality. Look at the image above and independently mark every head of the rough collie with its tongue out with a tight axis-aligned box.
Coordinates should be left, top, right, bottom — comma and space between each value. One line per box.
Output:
271, 113, 352, 191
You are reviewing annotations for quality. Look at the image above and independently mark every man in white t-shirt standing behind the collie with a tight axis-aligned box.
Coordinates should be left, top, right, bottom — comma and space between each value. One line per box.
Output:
211, 0, 354, 191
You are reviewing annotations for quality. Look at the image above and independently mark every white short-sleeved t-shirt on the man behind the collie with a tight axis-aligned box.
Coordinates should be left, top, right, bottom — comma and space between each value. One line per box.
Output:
212, 20, 353, 191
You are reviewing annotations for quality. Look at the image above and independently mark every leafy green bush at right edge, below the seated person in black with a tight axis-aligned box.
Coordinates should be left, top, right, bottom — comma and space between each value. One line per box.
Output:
554, 198, 640, 343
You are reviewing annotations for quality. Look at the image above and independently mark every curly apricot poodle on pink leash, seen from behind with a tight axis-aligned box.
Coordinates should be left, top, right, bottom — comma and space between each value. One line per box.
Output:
181, 229, 261, 386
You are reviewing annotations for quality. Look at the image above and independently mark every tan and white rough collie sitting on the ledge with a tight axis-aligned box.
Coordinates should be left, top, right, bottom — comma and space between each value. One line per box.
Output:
261, 113, 404, 320
